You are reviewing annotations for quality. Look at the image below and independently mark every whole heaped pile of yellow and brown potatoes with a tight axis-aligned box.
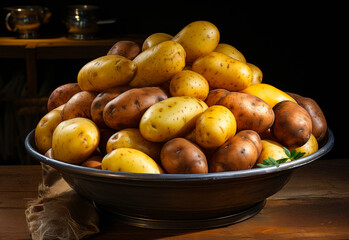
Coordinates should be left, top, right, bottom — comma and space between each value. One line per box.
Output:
35, 21, 327, 174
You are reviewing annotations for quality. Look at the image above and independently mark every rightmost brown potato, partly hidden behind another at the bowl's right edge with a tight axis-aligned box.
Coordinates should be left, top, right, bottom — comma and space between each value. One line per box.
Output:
288, 93, 327, 142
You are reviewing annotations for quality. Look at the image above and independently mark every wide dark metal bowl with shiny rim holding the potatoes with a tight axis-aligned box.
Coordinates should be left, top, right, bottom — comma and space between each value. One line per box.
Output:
25, 129, 334, 229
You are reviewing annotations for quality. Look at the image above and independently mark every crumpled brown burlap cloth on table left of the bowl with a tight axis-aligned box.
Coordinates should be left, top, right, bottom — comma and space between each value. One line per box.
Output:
25, 164, 99, 240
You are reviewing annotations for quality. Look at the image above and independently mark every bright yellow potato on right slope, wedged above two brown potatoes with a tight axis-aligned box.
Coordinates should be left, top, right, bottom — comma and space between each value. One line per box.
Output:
241, 83, 296, 107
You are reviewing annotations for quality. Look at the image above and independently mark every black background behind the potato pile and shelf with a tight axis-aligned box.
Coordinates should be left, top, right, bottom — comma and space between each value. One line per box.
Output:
0, 0, 348, 163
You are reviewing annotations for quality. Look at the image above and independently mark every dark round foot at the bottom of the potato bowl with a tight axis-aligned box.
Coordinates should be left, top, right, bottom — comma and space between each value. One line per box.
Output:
94, 200, 266, 229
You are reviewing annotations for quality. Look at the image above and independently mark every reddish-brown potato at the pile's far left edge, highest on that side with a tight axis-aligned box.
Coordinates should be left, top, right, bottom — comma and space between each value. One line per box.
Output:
47, 83, 81, 112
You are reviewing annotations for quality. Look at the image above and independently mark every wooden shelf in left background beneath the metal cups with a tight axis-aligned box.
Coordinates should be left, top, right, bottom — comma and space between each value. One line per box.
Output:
0, 36, 143, 97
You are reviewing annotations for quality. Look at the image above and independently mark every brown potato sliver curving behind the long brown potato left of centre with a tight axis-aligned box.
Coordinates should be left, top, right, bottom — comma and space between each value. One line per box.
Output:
91, 86, 130, 128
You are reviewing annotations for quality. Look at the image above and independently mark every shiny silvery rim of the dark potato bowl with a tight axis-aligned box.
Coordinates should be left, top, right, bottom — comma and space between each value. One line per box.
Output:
24, 128, 334, 182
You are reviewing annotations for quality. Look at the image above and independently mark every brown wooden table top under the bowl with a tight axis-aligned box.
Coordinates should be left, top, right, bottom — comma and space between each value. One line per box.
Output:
0, 159, 349, 240
